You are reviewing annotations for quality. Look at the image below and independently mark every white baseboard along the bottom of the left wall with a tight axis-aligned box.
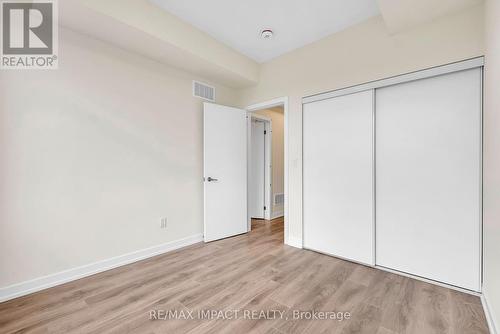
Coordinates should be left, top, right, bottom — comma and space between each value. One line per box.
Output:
0, 234, 203, 302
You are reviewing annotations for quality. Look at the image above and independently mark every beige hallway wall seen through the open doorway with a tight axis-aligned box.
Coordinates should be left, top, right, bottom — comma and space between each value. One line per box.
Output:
255, 107, 285, 217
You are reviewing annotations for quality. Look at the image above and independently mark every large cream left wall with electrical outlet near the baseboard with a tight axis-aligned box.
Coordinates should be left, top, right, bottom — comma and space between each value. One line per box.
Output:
0, 30, 239, 288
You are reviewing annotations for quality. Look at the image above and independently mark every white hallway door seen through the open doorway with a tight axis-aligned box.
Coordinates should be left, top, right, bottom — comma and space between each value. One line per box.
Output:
249, 120, 266, 219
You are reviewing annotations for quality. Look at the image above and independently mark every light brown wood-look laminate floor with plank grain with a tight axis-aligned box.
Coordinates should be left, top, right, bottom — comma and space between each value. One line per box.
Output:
0, 219, 488, 334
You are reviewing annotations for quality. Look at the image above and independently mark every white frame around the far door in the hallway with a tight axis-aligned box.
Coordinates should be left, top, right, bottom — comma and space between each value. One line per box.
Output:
247, 112, 273, 223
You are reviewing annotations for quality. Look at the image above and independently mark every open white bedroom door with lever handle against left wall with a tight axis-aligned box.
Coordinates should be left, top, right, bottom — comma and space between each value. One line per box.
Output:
203, 103, 247, 242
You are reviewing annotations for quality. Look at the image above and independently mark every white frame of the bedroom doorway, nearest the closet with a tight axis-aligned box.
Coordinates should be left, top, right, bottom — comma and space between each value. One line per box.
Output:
245, 96, 290, 248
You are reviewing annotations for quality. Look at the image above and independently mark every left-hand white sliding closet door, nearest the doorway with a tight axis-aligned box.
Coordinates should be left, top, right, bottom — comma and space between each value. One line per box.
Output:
303, 90, 373, 264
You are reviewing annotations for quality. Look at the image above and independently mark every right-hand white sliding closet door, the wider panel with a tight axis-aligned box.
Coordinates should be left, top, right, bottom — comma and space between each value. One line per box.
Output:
375, 69, 481, 291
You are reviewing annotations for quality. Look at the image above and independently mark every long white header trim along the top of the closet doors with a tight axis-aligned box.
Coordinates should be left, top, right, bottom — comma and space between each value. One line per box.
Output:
302, 57, 484, 104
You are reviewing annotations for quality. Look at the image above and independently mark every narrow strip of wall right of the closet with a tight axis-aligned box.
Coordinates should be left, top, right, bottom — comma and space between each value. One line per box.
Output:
483, 0, 500, 331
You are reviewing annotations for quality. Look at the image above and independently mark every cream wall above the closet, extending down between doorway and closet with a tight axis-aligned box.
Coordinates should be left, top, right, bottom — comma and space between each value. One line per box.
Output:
240, 6, 484, 245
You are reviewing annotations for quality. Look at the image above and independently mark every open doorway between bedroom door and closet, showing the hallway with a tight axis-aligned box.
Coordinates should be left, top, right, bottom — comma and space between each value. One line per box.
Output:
247, 98, 288, 243
